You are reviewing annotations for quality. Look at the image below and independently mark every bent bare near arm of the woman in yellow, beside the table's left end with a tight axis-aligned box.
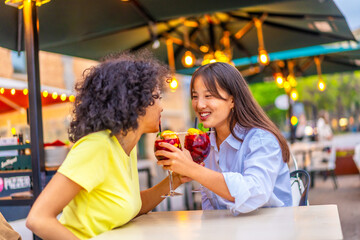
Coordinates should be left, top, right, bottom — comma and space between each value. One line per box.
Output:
26, 173, 82, 240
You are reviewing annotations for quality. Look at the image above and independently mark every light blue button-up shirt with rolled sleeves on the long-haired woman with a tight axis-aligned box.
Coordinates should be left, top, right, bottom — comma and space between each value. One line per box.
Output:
201, 125, 292, 215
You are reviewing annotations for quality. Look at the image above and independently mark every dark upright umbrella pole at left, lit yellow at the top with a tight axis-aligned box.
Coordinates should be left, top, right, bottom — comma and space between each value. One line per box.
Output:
23, 1, 45, 208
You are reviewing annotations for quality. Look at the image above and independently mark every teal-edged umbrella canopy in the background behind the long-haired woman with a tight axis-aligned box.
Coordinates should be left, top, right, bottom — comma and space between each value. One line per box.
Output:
236, 41, 360, 83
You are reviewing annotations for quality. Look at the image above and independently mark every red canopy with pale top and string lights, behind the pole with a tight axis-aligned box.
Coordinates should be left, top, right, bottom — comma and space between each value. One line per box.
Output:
0, 78, 75, 114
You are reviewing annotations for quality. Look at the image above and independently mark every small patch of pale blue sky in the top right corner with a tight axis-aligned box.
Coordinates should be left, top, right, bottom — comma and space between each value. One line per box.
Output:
334, 0, 360, 30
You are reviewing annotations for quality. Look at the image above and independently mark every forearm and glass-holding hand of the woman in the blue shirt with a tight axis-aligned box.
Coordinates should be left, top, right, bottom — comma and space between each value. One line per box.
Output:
155, 143, 235, 202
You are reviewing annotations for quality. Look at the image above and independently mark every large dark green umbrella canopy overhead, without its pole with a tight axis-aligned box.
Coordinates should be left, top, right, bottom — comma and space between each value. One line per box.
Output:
0, 0, 353, 73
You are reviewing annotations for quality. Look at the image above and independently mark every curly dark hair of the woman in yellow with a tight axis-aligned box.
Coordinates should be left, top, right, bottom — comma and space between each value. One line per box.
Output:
68, 51, 170, 142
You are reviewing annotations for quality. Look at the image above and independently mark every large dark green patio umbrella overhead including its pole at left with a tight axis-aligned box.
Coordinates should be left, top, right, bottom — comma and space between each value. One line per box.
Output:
0, 0, 353, 209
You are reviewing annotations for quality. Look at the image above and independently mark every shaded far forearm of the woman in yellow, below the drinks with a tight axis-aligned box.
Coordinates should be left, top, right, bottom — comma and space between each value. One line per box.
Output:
138, 174, 181, 215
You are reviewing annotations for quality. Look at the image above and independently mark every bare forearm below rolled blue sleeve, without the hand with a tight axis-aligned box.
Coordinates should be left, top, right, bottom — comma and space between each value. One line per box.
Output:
188, 165, 235, 202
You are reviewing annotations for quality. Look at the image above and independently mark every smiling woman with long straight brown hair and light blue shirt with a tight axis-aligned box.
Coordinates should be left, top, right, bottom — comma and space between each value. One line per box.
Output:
156, 62, 292, 215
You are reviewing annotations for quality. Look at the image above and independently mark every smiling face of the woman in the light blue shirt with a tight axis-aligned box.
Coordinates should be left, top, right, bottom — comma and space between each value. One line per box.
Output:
191, 76, 234, 132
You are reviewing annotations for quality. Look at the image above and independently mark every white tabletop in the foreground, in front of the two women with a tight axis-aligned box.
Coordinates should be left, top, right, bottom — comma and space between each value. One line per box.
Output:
93, 205, 343, 240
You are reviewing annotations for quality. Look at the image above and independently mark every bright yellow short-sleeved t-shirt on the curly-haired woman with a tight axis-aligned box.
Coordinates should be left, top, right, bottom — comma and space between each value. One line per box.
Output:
58, 130, 141, 239
